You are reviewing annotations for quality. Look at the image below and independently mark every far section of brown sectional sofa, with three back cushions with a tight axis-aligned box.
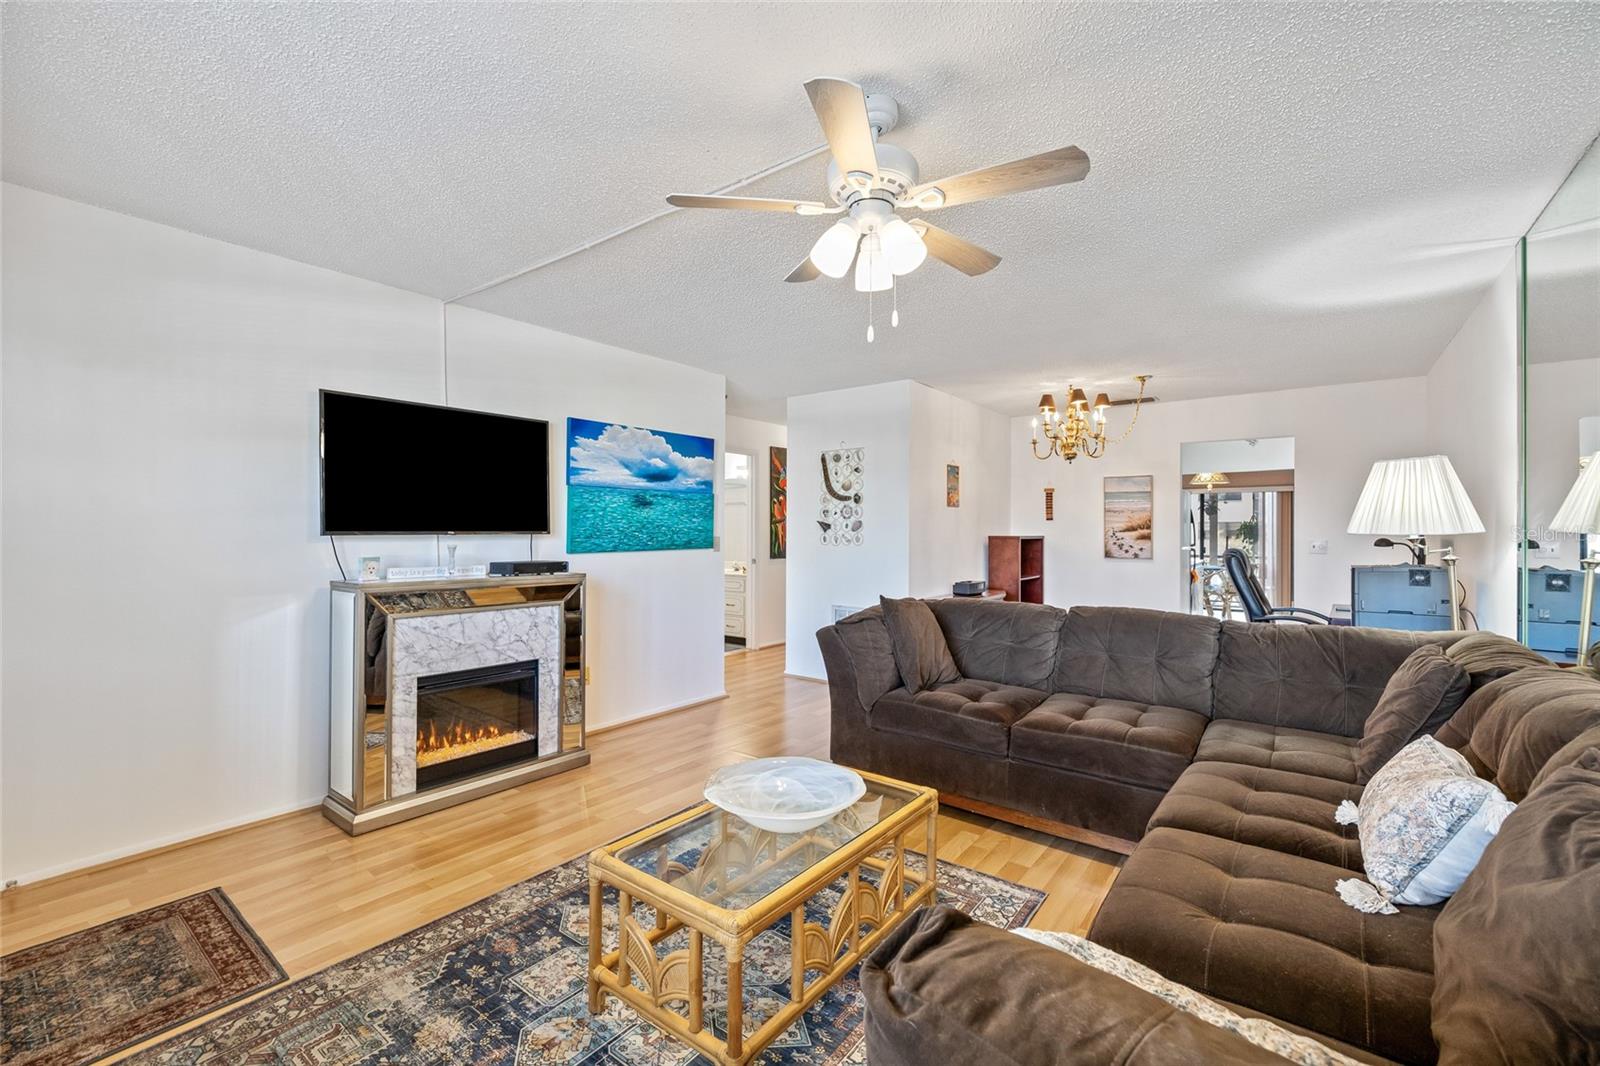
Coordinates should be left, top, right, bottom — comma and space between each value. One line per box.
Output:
818, 599, 1459, 852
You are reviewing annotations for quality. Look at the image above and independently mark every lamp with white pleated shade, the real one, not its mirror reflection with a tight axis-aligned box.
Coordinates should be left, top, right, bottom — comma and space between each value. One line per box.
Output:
1349, 455, 1483, 629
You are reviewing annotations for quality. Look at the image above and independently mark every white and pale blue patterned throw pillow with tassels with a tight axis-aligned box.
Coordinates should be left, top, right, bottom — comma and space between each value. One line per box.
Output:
1333, 736, 1517, 914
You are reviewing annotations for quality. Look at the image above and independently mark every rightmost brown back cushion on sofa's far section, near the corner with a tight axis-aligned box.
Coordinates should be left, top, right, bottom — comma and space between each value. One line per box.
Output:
1211, 621, 1456, 736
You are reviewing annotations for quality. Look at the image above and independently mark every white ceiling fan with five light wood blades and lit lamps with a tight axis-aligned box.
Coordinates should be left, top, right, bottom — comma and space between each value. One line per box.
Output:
667, 78, 1090, 341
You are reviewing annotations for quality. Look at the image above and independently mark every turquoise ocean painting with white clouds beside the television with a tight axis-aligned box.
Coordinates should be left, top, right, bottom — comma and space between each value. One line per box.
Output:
566, 418, 717, 552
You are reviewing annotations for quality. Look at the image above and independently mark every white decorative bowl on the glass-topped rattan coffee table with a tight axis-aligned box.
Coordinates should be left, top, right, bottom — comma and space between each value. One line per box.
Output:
706, 757, 867, 832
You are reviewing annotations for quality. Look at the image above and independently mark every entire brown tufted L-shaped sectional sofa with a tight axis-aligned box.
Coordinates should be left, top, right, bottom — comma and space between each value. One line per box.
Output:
819, 600, 1600, 1066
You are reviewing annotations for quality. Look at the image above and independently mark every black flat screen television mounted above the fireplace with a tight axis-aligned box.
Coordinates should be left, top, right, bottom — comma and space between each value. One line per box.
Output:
322, 389, 550, 536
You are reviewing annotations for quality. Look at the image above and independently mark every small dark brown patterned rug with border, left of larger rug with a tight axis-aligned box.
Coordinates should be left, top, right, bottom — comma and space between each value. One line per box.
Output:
0, 888, 285, 1066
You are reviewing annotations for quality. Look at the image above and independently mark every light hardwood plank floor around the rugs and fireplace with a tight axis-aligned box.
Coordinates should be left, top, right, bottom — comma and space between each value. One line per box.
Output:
0, 647, 1122, 1049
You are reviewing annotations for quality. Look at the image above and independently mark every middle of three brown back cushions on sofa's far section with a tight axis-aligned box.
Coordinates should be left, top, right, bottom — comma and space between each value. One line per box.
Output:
1051, 607, 1218, 715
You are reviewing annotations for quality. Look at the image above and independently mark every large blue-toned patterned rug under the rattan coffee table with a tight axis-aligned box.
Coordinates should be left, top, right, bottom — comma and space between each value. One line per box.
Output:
130, 853, 1045, 1066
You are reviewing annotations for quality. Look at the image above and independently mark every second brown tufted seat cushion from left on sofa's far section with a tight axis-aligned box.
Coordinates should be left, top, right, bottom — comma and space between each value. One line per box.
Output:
1011, 693, 1210, 787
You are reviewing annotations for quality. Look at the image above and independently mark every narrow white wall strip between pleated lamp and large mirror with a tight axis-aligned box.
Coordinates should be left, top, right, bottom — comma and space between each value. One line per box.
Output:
1427, 259, 1516, 637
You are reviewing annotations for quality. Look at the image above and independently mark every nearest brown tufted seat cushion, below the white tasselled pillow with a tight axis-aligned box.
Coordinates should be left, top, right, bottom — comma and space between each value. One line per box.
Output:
1090, 828, 1438, 1063
